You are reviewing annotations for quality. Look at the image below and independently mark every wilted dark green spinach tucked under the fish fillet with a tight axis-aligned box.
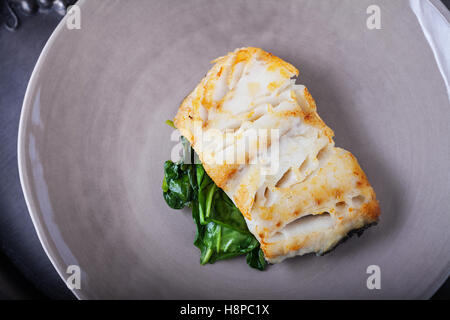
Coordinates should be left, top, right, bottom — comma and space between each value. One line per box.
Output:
162, 137, 267, 270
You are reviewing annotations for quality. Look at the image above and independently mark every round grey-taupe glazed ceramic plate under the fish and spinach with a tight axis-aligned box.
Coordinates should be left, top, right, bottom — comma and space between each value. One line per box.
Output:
19, 0, 450, 299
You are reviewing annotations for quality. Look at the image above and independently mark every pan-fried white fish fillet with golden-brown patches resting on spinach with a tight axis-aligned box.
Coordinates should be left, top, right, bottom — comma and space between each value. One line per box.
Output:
174, 47, 380, 263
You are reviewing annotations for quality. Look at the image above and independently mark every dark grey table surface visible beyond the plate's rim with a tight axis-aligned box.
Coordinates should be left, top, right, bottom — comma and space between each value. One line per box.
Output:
0, 0, 450, 299
